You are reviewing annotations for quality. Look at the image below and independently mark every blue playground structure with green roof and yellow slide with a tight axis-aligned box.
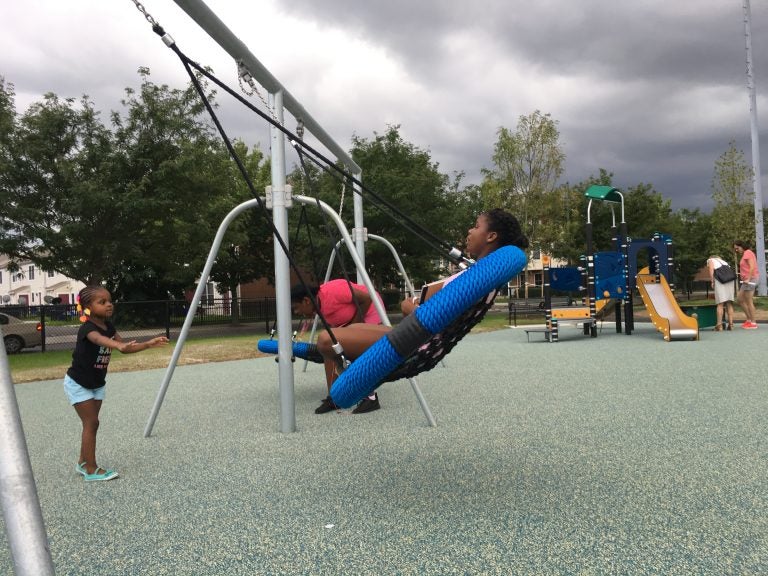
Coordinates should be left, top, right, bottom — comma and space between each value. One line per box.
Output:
543, 185, 699, 342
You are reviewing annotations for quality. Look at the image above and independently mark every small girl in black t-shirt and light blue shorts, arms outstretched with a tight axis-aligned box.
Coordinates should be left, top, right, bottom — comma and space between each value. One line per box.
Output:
64, 286, 168, 482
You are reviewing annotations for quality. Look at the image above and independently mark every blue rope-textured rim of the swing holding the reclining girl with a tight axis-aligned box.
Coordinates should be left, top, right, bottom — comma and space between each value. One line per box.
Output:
331, 246, 526, 408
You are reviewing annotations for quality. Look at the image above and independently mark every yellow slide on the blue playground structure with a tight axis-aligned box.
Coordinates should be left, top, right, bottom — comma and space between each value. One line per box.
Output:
637, 273, 699, 342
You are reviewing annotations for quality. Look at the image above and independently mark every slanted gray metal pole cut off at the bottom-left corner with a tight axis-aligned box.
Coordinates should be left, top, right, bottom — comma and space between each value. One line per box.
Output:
0, 346, 54, 576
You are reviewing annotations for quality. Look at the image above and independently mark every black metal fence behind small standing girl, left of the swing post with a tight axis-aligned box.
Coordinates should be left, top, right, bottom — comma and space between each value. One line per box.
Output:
0, 297, 276, 352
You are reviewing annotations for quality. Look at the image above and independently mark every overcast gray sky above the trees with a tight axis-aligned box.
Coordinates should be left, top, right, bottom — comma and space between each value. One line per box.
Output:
0, 0, 768, 212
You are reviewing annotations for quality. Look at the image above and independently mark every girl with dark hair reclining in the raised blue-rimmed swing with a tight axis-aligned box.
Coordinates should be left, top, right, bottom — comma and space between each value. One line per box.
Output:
317, 208, 528, 407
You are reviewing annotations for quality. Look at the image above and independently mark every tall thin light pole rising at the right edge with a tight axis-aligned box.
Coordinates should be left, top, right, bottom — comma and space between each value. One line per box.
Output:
744, 0, 766, 296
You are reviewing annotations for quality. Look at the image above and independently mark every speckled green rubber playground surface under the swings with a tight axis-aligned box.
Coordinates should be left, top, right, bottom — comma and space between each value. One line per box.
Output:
0, 324, 768, 575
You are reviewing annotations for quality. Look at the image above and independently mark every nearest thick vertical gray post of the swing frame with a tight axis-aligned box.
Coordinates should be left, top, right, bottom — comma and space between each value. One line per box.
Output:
269, 92, 296, 434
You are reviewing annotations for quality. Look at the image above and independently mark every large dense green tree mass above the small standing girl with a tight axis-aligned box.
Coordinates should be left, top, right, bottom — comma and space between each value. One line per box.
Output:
0, 69, 255, 299
